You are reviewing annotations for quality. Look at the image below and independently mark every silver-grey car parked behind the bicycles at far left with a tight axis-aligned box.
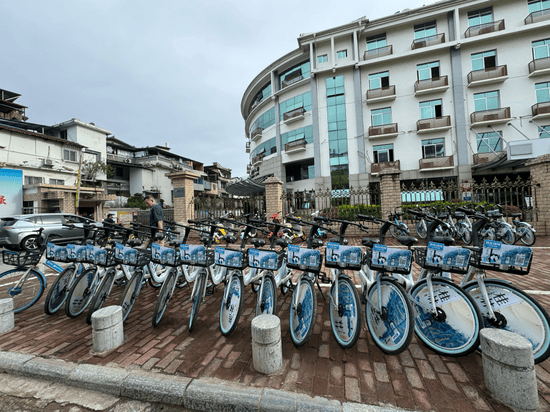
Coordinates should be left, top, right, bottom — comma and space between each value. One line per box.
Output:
0, 213, 101, 250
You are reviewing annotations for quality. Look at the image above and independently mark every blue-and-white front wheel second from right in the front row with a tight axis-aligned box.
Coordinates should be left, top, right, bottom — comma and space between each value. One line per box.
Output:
410, 277, 483, 356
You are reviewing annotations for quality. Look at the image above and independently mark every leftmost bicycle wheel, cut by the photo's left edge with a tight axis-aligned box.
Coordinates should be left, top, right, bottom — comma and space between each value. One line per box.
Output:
0, 268, 45, 313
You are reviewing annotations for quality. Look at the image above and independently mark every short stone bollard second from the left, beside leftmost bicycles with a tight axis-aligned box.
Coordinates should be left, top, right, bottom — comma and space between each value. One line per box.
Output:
92, 306, 124, 353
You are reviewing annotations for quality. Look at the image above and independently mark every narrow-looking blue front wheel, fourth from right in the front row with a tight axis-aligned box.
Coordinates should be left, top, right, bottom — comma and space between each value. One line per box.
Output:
330, 276, 361, 349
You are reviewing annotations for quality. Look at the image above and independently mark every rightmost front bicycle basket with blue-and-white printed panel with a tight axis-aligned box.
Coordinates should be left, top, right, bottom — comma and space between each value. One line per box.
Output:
470, 240, 533, 275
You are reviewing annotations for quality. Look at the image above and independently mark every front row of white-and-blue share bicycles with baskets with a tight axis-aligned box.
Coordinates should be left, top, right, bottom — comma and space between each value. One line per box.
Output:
0, 204, 550, 363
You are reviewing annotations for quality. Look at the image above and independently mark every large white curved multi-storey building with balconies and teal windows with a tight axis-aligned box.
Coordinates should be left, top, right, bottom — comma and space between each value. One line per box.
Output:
241, 0, 550, 189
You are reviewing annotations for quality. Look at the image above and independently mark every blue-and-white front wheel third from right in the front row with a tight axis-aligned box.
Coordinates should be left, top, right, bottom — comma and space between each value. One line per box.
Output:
365, 279, 414, 355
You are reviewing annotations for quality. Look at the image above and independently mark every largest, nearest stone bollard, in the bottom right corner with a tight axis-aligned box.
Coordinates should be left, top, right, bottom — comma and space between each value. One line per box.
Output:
481, 328, 539, 410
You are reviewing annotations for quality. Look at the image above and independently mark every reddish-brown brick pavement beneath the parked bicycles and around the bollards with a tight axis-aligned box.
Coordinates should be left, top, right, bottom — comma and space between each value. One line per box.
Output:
0, 238, 550, 412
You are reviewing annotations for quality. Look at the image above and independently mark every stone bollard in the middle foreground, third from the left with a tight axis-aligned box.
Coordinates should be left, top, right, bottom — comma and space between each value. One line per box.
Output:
252, 315, 283, 375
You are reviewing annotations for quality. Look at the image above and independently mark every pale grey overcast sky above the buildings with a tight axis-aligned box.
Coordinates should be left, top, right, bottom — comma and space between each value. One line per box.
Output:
0, 0, 432, 176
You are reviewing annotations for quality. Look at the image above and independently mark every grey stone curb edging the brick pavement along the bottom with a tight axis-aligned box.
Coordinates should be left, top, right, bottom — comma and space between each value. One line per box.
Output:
0, 351, 410, 412
